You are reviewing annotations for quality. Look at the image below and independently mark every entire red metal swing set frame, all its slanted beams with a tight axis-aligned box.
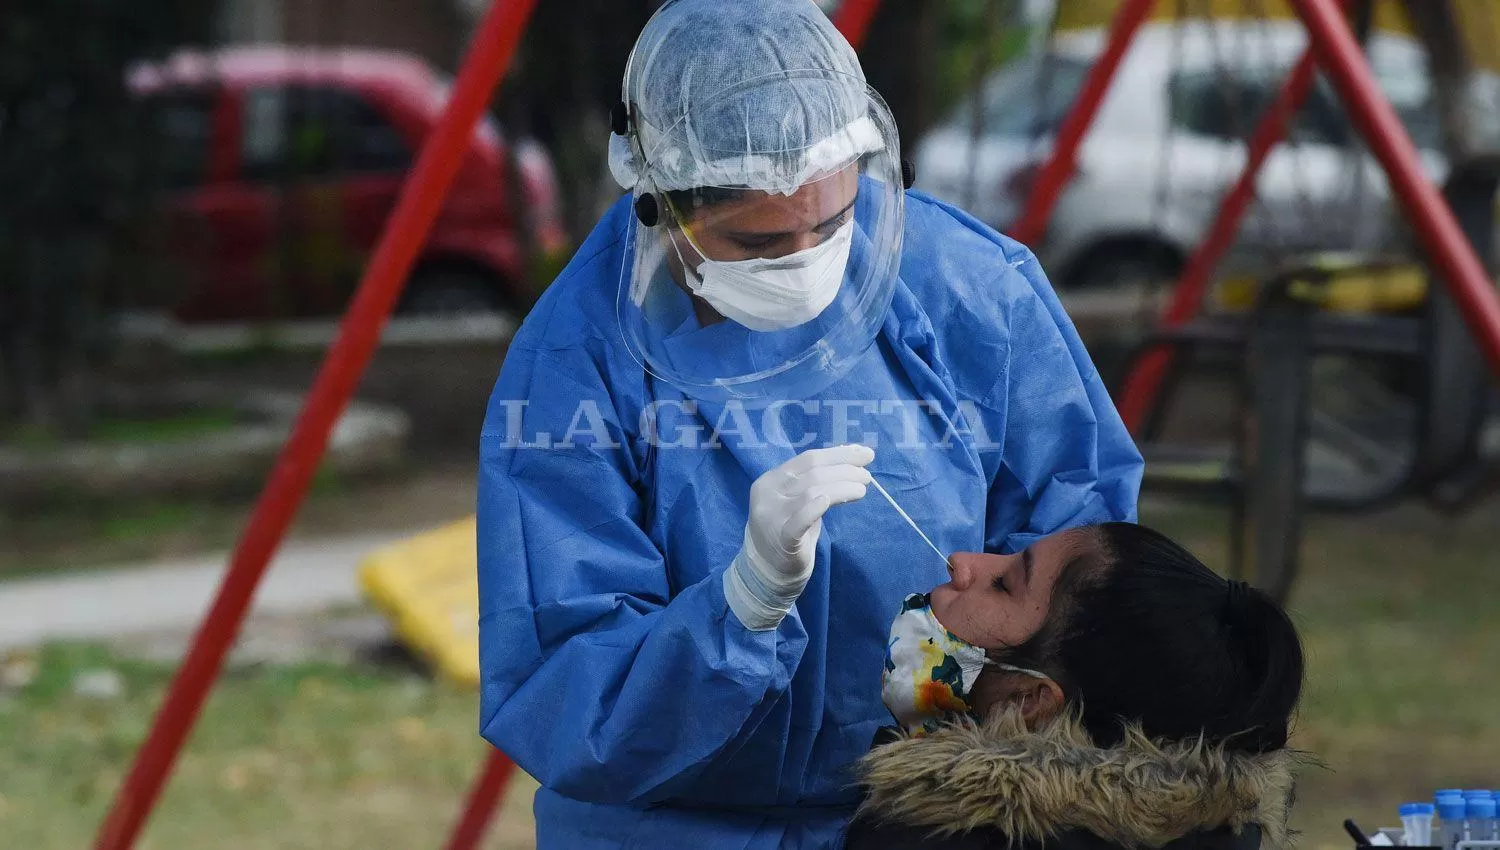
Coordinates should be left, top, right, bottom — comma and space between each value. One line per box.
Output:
95, 0, 1500, 850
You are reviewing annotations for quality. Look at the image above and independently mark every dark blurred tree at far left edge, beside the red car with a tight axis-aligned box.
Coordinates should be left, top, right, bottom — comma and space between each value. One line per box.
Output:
0, 0, 213, 433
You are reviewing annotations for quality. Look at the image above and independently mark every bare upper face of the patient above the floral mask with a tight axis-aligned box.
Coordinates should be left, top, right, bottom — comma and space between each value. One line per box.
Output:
932, 531, 1098, 649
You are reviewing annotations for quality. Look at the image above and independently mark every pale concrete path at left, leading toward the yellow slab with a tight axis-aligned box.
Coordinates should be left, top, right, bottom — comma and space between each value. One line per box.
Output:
0, 534, 405, 652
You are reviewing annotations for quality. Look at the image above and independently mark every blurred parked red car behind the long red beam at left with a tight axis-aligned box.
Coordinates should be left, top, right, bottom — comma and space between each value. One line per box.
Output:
128, 46, 566, 321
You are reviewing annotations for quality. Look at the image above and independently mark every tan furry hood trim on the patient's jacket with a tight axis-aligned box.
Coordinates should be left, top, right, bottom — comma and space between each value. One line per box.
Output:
858, 714, 1299, 847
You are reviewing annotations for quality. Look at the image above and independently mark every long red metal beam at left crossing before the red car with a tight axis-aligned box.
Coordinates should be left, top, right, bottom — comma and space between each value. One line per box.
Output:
85, 0, 536, 850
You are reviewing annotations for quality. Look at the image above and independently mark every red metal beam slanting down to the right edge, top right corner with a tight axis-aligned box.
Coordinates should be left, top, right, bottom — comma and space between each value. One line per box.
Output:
1292, 0, 1500, 376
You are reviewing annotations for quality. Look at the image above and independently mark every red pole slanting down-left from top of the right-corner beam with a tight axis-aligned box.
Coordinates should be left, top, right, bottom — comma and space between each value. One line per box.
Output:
1119, 46, 1317, 432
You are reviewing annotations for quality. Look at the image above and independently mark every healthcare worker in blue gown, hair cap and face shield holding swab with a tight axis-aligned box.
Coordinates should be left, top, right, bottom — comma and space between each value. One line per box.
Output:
479, 0, 1142, 850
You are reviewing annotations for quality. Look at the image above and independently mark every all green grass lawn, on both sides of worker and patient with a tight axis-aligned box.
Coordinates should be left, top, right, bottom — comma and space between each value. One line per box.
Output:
0, 508, 1500, 850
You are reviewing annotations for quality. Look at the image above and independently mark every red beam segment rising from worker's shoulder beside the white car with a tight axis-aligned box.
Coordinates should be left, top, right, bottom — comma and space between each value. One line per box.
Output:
1010, 0, 1155, 244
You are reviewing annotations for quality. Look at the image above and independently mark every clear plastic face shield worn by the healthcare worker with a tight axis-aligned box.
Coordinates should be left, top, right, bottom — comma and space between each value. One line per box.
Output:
617, 70, 905, 403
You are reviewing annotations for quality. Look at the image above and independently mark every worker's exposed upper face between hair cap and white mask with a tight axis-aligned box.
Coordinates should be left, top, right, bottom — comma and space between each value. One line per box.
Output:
669, 165, 860, 265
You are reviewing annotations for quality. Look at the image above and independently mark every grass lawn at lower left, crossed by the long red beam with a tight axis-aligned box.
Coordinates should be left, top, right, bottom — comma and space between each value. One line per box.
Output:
0, 646, 533, 850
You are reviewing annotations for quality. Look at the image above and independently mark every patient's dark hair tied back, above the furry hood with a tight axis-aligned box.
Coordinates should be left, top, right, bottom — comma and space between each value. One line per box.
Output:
996, 523, 1304, 753
